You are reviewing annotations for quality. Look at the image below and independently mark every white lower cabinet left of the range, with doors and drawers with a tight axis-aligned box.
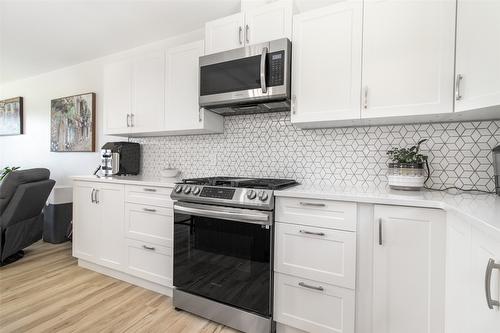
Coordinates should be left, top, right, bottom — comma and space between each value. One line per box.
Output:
73, 181, 173, 290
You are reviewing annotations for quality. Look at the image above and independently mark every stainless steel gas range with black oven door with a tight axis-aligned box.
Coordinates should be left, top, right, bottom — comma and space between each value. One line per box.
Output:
171, 177, 298, 333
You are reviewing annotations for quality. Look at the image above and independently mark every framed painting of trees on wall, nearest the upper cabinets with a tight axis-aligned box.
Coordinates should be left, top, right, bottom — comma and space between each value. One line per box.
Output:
50, 93, 95, 152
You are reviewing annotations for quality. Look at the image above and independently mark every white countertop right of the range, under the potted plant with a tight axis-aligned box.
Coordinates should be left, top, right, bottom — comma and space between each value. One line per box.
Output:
274, 185, 500, 233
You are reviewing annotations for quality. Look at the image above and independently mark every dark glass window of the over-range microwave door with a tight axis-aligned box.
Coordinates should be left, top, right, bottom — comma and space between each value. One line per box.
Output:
200, 55, 261, 96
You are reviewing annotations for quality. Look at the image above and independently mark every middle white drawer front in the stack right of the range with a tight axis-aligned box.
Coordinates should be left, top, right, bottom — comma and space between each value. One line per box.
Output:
274, 223, 356, 289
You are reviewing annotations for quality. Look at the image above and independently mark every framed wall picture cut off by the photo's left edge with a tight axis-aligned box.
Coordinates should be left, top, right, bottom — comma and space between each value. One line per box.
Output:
0, 97, 23, 135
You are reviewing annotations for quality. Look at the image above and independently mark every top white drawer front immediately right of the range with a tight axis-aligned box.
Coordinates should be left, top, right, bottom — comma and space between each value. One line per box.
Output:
276, 198, 357, 231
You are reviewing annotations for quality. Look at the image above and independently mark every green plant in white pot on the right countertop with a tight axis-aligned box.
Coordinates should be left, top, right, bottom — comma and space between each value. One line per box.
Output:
387, 139, 428, 191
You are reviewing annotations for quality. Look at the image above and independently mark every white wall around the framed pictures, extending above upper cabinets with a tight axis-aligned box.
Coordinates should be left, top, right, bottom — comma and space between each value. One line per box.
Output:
0, 30, 203, 185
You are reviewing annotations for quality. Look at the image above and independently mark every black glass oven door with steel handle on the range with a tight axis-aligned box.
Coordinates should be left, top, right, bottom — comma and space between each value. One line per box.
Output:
174, 202, 273, 317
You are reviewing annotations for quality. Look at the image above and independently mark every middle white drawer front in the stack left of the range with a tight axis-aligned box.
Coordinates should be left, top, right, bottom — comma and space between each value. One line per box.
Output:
125, 203, 174, 247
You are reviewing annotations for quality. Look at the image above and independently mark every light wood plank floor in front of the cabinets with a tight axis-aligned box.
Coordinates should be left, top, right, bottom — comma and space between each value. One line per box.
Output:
0, 242, 240, 333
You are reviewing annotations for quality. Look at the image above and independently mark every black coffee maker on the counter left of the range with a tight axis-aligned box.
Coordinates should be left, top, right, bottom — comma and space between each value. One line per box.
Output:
100, 142, 141, 177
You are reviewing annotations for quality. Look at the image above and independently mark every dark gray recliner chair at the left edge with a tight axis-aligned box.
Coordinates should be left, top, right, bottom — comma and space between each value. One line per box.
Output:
0, 169, 56, 266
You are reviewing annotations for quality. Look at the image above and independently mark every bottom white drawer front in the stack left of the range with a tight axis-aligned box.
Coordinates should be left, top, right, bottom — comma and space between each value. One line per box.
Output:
127, 240, 173, 287
